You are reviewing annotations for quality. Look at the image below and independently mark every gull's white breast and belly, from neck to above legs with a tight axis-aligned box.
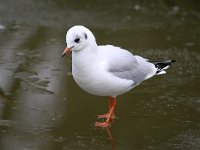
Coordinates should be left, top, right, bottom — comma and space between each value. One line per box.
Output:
72, 50, 133, 96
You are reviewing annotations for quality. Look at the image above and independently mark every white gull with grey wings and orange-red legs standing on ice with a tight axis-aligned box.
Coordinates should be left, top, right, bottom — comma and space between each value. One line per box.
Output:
62, 25, 175, 128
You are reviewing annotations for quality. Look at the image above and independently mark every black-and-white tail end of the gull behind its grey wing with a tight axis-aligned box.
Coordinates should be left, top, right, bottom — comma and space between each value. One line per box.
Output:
150, 60, 176, 75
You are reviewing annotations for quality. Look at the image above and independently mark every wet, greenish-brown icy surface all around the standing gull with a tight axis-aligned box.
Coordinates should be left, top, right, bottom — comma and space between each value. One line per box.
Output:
0, 0, 200, 150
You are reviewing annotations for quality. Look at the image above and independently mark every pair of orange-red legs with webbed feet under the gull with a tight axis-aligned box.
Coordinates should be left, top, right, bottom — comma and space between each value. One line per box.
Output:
95, 97, 117, 128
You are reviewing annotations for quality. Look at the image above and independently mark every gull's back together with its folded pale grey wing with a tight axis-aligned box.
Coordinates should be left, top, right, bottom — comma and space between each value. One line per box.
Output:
99, 45, 156, 85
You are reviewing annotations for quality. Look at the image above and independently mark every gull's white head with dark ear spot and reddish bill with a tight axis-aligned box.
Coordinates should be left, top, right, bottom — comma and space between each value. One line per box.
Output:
62, 25, 96, 56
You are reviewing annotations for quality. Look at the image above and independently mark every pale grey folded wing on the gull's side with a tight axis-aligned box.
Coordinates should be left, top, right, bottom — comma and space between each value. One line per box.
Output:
109, 52, 156, 85
